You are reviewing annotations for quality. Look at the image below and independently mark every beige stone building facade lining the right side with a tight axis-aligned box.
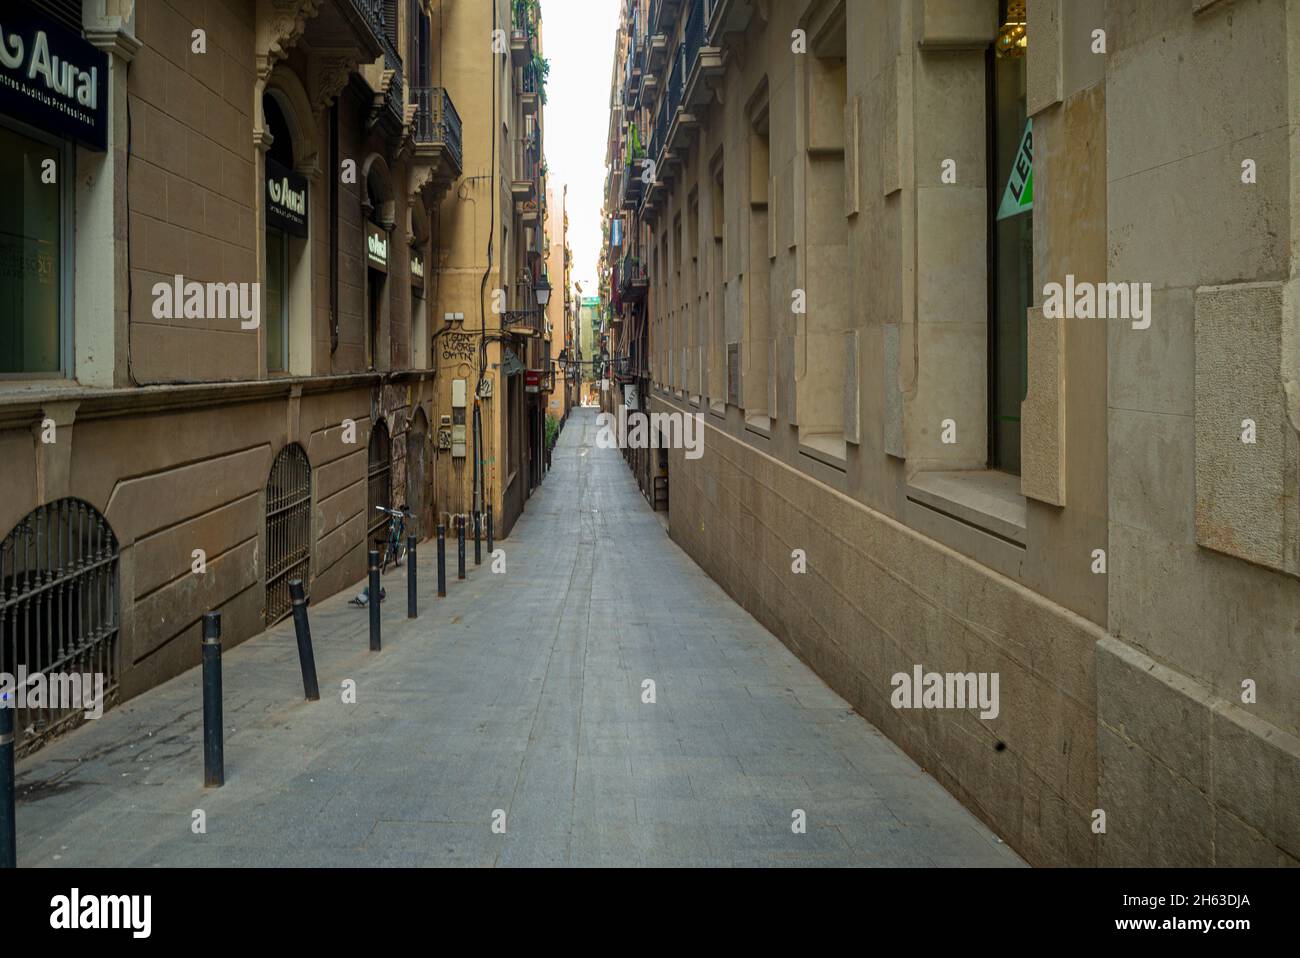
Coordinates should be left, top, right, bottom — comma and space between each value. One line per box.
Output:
607, 0, 1300, 866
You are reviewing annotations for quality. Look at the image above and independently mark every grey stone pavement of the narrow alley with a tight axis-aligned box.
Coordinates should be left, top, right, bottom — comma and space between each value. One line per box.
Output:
18, 409, 1022, 866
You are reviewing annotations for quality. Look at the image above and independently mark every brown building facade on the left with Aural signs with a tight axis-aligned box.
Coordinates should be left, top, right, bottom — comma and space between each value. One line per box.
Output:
0, 0, 542, 750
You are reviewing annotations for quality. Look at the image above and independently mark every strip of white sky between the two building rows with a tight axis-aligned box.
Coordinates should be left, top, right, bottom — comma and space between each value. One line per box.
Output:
542, 0, 620, 296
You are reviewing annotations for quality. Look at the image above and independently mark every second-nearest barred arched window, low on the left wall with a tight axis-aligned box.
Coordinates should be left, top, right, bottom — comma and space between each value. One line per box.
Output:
265, 442, 312, 625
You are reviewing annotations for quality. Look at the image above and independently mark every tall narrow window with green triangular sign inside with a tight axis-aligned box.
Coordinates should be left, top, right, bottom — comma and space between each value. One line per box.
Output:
988, 0, 1034, 474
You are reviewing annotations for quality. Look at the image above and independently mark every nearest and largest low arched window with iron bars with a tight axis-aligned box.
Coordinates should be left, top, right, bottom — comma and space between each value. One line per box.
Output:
0, 499, 118, 754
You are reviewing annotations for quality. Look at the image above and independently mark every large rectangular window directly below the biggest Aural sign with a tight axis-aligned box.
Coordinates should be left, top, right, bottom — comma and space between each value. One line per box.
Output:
0, 125, 73, 376
